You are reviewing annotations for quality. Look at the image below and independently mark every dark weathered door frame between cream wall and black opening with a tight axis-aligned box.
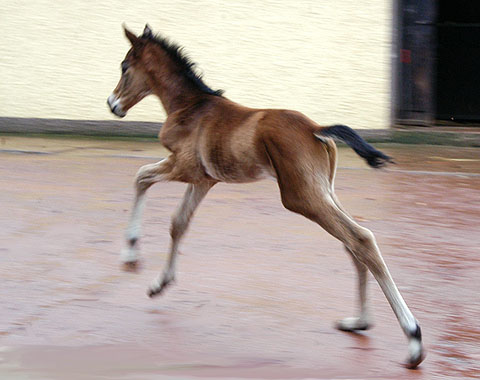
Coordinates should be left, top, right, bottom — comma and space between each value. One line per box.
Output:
390, 0, 438, 126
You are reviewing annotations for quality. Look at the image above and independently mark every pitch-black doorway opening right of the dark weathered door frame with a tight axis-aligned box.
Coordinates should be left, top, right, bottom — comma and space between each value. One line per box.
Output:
435, 0, 480, 121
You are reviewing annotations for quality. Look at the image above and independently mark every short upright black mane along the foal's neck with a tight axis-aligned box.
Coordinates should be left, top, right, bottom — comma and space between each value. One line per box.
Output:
144, 35, 224, 96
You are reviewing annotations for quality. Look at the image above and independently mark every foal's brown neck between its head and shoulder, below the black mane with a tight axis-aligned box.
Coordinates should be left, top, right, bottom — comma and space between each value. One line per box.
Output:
145, 45, 205, 115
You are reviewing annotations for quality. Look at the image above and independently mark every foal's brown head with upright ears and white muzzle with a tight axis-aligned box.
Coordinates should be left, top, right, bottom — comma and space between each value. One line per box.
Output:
107, 25, 152, 117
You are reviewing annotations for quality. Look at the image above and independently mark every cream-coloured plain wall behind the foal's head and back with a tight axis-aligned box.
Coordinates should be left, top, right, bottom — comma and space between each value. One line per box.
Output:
0, 0, 391, 128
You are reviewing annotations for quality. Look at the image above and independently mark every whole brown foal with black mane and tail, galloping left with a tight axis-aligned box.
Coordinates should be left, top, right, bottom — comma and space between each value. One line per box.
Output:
108, 25, 424, 368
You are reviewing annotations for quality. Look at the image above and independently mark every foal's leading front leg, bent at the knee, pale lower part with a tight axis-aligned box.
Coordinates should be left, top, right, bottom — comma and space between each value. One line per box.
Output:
121, 156, 174, 267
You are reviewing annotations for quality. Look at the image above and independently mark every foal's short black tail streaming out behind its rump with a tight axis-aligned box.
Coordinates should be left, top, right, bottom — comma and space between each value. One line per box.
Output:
315, 125, 394, 168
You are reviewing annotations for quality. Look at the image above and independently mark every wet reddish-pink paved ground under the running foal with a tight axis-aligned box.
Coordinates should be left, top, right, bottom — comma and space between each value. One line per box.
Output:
0, 136, 480, 379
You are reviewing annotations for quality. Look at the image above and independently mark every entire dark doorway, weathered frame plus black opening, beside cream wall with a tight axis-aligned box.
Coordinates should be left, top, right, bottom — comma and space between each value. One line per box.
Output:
392, 0, 480, 125
